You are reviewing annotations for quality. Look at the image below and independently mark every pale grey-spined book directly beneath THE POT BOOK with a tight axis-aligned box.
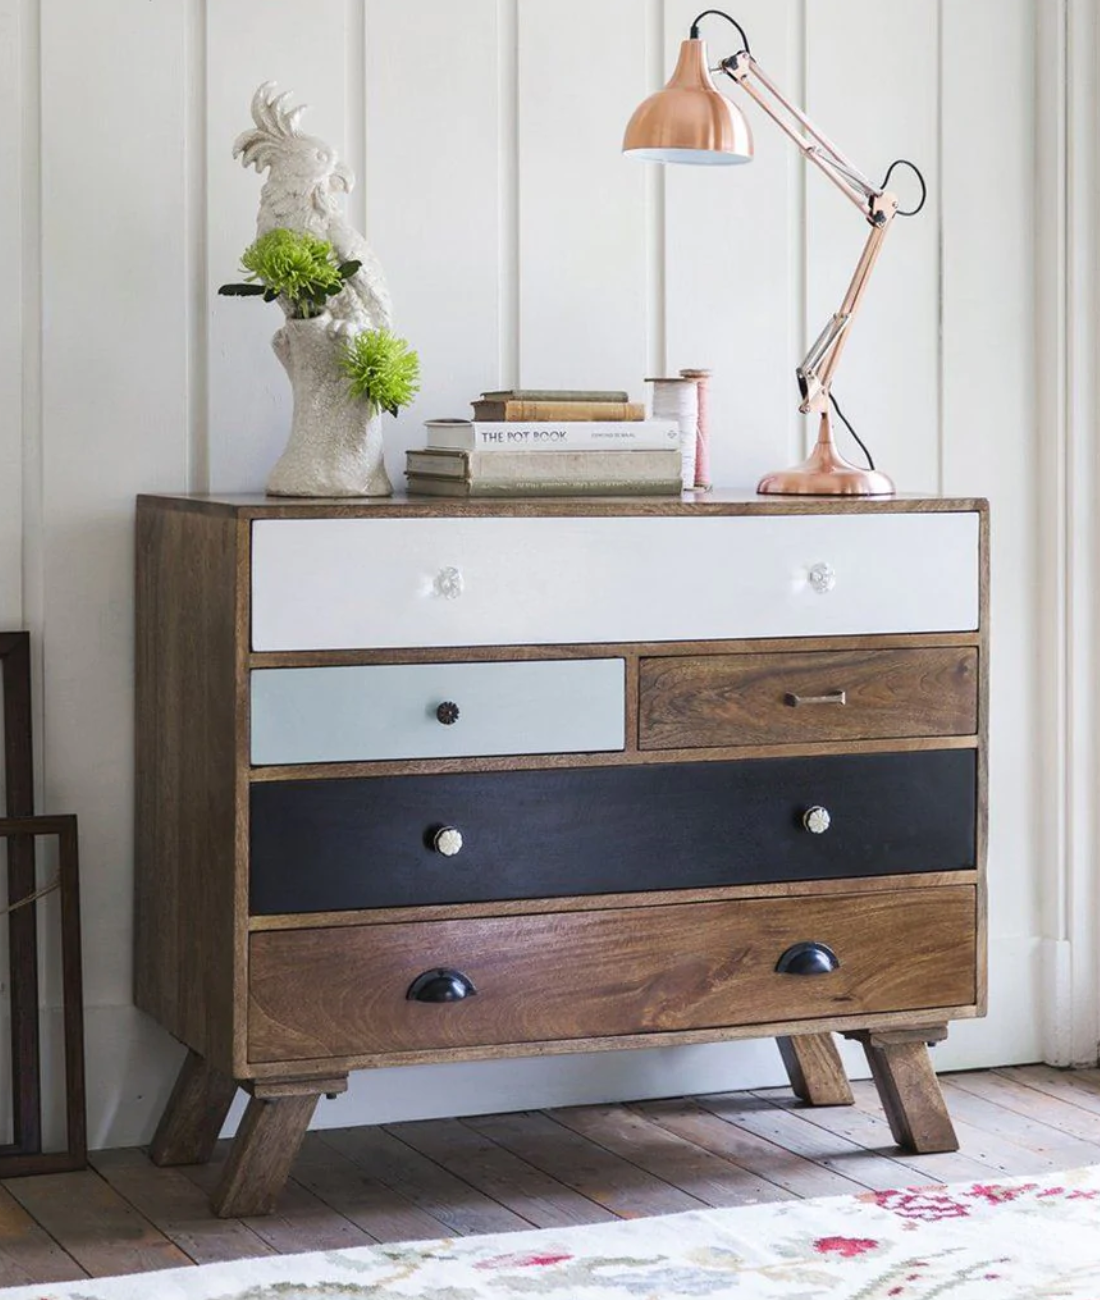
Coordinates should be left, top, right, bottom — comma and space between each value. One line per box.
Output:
406, 447, 680, 484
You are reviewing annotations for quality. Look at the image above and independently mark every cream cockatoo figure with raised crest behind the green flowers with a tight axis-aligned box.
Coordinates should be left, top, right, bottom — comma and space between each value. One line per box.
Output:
233, 82, 393, 334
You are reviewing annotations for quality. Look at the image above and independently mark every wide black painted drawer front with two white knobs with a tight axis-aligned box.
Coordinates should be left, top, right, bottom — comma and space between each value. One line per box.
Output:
251, 749, 976, 915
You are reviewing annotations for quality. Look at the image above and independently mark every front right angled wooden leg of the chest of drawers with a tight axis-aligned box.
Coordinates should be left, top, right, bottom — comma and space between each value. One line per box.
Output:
845, 1026, 958, 1154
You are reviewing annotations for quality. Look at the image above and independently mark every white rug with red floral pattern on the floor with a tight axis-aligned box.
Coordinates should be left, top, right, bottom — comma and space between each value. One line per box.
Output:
8, 1166, 1100, 1300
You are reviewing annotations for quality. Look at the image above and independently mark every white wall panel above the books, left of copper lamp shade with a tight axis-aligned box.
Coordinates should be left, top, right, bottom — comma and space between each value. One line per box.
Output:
517, 0, 650, 395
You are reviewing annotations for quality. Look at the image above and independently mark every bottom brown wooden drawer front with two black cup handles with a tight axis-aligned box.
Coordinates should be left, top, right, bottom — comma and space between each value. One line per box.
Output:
248, 885, 975, 1062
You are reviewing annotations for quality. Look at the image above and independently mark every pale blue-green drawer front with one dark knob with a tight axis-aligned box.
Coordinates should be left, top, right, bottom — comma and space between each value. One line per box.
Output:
251, 659, 625, 767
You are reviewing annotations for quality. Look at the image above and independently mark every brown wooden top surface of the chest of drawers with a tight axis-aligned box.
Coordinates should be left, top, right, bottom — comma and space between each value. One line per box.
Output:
138, 489, 988, 519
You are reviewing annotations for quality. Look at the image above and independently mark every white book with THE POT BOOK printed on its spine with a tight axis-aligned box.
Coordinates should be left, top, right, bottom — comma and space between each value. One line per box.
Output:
424, 420, 680, 454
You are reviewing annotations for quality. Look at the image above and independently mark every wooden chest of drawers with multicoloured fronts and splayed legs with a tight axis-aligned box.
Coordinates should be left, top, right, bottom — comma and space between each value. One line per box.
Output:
135, 494, 988, 1216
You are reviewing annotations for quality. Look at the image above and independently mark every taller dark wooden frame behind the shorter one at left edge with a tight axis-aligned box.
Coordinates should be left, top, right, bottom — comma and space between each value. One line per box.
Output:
0, 632, 42, 1158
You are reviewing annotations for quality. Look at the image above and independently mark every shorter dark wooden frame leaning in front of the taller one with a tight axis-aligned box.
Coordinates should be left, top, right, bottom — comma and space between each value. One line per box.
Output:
0, 814, 87, 1178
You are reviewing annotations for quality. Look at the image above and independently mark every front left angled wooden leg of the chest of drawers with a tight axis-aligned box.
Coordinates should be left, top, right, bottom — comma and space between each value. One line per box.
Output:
211, 1075, 347, 1218
